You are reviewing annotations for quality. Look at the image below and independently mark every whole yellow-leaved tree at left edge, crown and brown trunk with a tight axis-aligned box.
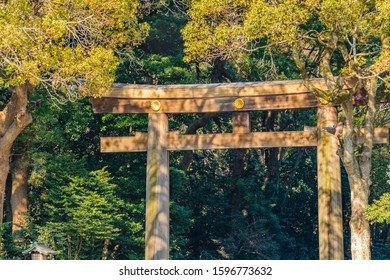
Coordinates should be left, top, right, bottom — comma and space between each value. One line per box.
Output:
0, 0, 147, 223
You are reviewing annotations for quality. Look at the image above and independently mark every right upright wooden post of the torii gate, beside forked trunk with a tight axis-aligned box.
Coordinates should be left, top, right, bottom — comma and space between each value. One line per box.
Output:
317, 106, 344, 260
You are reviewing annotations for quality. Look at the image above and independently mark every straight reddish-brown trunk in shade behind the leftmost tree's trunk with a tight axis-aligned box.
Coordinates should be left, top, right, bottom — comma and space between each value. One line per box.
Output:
11, 156, 28, 242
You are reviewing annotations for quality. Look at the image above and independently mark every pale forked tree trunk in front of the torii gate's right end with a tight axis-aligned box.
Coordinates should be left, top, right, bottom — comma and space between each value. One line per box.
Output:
342, 78, 377, 260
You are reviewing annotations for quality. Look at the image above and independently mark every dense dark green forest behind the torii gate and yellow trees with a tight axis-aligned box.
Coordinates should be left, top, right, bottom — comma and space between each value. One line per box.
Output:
0, 1, 390, 260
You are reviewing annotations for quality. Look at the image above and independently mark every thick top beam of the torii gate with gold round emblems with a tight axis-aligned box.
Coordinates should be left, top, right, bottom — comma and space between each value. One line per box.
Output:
91, 79, 348, 114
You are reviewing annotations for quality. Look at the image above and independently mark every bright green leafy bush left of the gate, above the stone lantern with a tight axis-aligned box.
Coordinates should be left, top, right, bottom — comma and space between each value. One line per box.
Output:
38, 169, 123, 259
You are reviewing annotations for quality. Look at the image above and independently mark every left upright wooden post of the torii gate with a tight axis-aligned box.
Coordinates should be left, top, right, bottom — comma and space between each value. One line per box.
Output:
145, 113, 169, 260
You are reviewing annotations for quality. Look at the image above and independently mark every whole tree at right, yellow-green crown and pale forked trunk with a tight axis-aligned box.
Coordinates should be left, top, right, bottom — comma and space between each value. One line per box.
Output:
183, 0, 390, 259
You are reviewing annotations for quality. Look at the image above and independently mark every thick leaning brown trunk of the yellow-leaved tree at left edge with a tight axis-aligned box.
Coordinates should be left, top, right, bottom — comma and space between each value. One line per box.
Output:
0, 84, 32, 224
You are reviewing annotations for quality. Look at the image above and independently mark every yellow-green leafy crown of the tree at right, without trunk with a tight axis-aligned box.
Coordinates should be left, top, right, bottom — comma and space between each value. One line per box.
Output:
183, 0, 390, 86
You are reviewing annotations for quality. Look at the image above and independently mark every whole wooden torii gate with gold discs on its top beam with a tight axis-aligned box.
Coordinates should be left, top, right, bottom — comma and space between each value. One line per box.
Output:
91, 79, 389, 260
